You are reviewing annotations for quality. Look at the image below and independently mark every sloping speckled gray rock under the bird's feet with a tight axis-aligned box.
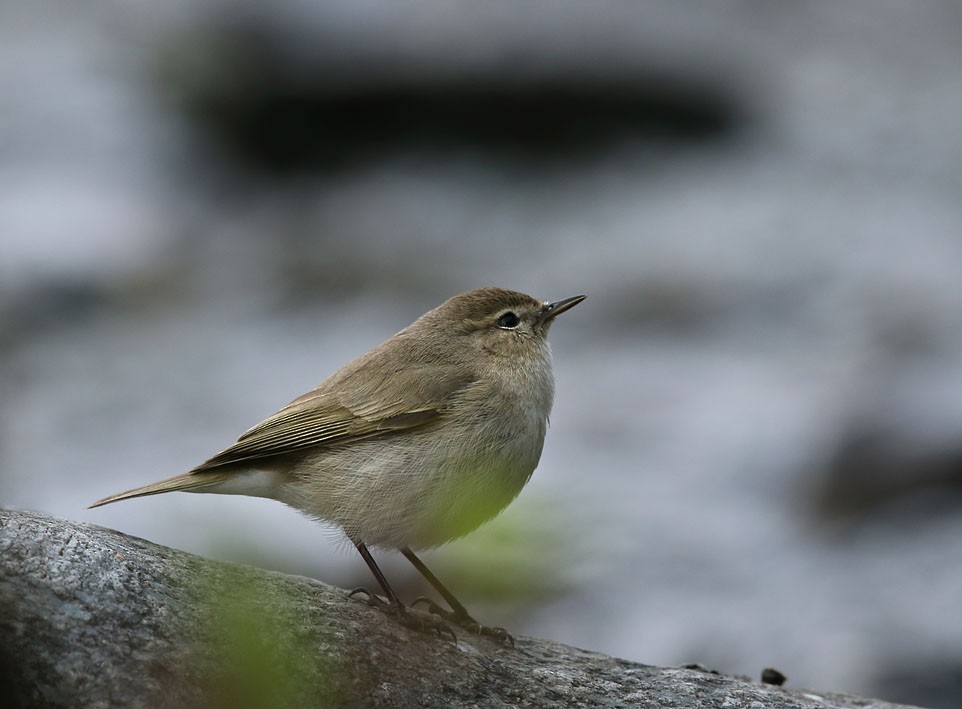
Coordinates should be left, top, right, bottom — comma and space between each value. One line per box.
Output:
0, 510, 916, 709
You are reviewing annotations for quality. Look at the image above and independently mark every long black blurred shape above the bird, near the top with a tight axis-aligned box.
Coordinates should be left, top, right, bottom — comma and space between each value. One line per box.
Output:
154, 24, 740, 175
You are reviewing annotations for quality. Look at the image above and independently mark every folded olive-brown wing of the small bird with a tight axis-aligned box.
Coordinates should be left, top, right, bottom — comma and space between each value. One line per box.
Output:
191, 336, 473, 472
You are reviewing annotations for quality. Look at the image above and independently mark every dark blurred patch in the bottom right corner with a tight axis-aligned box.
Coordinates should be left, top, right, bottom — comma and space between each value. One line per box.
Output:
873, 656, 962, 709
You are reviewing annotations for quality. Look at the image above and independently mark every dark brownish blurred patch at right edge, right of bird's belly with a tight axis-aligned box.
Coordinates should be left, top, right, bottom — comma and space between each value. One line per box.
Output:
812, 424, 962, 523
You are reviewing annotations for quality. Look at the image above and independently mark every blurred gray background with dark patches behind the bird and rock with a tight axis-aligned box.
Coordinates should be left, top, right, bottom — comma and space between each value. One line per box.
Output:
0, 0, 962, 707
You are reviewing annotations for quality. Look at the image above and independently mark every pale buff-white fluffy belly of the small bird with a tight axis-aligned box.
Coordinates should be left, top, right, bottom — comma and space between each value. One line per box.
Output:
280, 417, 546, 549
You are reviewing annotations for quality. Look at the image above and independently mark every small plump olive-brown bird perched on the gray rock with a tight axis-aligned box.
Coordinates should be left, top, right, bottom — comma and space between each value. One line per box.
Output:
91, 288, 585, 638
